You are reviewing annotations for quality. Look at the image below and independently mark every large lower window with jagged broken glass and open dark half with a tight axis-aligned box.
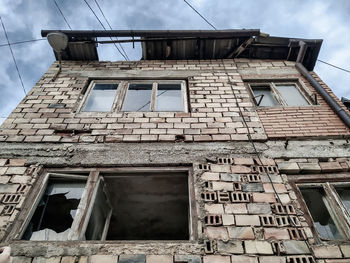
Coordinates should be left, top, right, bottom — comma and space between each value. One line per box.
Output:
21, 168, 194, 241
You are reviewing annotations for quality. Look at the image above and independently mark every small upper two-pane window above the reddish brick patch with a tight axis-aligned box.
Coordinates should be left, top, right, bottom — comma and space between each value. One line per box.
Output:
249, 82, 310, 106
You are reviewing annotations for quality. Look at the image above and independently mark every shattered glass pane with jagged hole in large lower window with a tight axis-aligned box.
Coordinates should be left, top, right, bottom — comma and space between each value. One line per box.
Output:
23, 180, 85, 240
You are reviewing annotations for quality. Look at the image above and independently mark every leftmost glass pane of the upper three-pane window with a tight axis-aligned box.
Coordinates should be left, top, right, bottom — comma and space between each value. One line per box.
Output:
83, 84, 118, 111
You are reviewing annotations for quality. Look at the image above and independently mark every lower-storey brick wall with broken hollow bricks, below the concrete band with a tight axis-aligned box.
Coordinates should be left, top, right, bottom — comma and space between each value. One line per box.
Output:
0, 156, 350, 263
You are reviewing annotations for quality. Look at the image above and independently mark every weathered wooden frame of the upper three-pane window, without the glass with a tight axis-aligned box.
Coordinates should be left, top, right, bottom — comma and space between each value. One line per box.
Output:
77, 79, 189, 113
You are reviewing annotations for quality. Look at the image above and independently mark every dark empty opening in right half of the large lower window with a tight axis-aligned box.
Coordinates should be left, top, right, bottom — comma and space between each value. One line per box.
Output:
98, 173, 190, 240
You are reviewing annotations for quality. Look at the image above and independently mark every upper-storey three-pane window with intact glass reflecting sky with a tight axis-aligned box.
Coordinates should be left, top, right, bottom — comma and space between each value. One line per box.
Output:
80, 80, 188, 112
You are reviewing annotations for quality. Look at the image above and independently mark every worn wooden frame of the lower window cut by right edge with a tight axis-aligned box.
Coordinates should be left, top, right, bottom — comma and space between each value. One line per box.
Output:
287, 173, 350, 244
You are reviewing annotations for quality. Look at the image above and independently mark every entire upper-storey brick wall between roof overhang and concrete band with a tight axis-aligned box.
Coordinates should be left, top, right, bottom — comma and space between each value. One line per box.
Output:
0, 59, 349, 143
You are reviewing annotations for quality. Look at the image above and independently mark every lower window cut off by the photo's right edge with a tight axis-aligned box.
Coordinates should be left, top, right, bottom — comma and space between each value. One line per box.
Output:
298, 182, 350, 240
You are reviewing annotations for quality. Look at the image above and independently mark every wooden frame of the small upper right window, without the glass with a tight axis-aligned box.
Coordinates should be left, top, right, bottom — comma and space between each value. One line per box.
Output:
248, 80, 317, 108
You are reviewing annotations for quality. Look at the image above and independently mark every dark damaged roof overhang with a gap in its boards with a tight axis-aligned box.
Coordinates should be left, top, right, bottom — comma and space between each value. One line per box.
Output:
41, 29, 322, 70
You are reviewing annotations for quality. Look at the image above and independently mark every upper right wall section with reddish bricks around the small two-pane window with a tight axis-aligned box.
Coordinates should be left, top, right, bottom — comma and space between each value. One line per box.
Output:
237, 61, 350, 139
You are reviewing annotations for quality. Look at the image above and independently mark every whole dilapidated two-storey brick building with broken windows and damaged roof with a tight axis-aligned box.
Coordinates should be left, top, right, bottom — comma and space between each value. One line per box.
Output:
0, 29, 350, 263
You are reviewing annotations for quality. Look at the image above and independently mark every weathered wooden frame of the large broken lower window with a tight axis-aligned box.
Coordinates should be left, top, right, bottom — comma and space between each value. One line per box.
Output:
6, 166, 198, 243
